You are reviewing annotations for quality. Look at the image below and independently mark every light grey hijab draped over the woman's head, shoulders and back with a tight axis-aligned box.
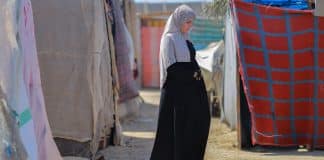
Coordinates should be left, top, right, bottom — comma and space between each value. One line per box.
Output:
160, 5, 196, 88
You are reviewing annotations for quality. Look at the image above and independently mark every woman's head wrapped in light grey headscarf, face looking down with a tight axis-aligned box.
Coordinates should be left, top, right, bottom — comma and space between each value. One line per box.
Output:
164, 5, 196, 34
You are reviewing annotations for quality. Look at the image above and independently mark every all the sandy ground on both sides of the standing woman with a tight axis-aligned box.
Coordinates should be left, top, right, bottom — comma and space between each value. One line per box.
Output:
69, 90, 324, 160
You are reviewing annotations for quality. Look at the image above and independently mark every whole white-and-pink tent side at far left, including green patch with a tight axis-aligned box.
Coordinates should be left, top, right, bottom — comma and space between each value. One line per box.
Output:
0, 0, 61, 160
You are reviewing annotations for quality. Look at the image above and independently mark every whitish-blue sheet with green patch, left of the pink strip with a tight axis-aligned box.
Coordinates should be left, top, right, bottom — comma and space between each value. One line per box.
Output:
0, 1, 38, 160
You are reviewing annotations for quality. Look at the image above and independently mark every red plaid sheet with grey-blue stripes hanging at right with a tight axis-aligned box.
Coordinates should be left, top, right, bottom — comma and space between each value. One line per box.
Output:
232, 0, 324, 147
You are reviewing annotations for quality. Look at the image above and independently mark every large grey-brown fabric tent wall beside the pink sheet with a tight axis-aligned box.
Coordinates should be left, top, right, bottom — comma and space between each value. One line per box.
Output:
32, 0, 118, 156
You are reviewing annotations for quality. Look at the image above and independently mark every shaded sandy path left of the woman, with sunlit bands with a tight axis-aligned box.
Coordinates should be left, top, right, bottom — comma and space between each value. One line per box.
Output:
105, 90, 160, 160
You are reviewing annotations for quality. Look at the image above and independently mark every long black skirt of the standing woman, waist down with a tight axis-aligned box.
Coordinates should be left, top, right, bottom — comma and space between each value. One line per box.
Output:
151, 63, 210, 160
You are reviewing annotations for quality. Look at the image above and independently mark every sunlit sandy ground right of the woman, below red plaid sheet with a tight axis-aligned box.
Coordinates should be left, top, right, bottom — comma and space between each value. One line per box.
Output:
205, 118, 324, 160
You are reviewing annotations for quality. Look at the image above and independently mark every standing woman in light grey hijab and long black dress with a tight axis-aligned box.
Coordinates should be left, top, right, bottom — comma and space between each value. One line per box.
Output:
151, 5, 210, 160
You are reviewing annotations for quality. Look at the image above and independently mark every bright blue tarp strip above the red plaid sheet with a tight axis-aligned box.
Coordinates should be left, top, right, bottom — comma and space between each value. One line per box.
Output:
244, 0, 308, 10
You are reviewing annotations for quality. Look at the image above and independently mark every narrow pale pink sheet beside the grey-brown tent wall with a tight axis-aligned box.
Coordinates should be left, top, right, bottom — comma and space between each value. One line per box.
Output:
20, 0, 61, 160
